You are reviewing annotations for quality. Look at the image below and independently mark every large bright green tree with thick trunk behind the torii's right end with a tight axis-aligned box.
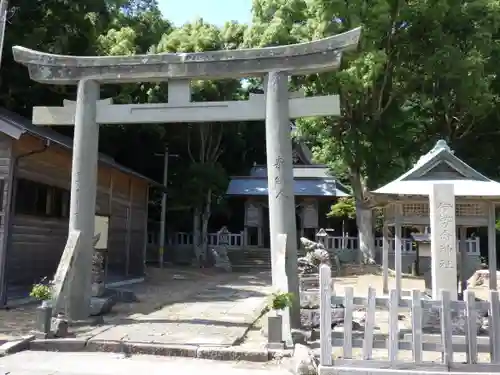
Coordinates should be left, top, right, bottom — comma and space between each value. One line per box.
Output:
247, 0, 500, 262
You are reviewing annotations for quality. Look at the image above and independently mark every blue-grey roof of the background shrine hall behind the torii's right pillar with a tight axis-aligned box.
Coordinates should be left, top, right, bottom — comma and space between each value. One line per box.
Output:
226, 176, 349, 197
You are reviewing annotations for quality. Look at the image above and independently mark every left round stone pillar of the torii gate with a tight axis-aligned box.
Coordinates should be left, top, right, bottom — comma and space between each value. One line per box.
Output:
66, 80, 99, 320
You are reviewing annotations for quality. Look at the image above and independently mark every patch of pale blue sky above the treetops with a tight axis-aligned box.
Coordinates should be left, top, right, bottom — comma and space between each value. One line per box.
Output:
158, 0, 252, 26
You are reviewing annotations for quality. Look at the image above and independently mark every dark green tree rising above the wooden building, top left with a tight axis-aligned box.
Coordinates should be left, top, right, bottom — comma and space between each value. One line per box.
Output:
0, 0, 110, 113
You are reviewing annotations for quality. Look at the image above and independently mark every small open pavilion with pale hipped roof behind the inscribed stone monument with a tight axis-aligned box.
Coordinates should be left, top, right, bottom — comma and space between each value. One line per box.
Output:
372, 140, 500, 292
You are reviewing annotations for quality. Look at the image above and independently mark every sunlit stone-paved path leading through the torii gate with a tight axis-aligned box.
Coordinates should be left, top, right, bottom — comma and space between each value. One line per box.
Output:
85, 272, 271, 346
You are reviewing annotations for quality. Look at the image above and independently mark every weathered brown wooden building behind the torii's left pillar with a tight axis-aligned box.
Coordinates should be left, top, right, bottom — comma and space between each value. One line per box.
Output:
0, 109, 158, 299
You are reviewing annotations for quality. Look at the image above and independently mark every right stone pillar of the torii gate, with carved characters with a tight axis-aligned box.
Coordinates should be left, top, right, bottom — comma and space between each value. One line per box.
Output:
265, 71, 300, 328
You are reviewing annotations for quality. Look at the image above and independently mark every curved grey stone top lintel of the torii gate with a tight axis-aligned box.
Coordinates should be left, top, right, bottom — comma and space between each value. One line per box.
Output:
12, 27, 361, 85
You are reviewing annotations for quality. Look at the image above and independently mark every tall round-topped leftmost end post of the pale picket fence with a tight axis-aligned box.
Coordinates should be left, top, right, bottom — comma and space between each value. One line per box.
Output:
319, 264, 333, 366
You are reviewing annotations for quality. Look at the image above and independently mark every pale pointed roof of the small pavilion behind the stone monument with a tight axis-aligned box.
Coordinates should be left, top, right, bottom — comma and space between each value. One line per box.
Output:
373, 140, 500, 198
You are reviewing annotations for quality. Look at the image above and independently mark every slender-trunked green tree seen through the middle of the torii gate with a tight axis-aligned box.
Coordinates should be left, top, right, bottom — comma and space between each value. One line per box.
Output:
151, 19, 245, 262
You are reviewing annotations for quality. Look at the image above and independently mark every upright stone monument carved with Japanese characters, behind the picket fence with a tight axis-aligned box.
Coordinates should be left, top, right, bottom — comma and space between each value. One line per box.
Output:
429, 184, 457, 299
